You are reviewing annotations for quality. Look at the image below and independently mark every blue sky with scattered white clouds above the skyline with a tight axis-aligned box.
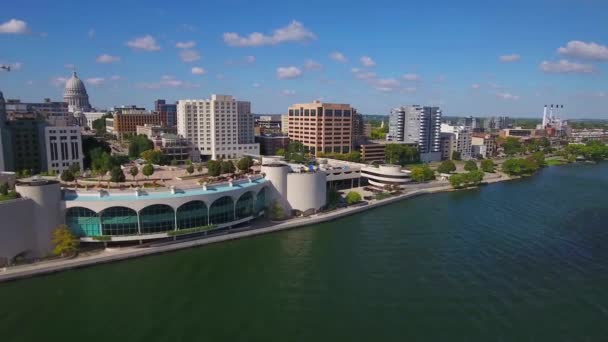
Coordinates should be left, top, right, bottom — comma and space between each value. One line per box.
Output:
0, 0, 608, 119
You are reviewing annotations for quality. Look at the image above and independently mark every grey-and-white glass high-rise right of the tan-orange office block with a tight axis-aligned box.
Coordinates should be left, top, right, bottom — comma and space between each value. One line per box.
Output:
387, 105, 441, 162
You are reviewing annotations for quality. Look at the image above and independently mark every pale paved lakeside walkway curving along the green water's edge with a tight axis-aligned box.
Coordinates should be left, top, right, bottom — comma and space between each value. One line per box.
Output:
0, 175, 519, 283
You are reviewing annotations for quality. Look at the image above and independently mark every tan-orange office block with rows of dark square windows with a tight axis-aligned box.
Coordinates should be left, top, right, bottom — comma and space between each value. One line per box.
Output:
288, 101, 357, 155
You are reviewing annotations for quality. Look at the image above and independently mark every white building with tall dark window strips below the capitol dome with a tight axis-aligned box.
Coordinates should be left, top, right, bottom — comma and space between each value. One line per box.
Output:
44, 126, 84, 174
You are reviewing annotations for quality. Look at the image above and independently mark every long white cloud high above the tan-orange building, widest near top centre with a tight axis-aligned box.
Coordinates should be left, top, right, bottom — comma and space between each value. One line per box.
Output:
224, 20, 317, 47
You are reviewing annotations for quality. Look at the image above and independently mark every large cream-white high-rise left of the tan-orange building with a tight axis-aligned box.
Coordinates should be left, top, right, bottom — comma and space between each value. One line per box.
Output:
177, 95, 260, 159
